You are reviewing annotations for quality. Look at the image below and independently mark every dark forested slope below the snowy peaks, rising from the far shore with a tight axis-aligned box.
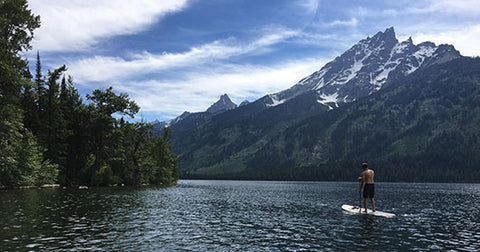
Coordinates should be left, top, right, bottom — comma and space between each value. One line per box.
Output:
180, 57, 480, 182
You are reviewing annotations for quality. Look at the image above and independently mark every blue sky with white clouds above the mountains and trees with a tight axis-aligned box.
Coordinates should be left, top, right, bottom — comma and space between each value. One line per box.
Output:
25, 0, 480, 122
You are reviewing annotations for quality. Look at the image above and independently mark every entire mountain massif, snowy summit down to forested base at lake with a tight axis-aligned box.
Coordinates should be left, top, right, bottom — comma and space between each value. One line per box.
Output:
155, 28, 480, 181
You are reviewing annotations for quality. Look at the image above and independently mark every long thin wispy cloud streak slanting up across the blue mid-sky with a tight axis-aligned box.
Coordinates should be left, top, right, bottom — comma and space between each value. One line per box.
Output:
69, 29, 297, 82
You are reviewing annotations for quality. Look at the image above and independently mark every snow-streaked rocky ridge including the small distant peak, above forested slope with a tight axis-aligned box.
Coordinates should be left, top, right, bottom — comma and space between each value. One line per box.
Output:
154, 27, 462, 134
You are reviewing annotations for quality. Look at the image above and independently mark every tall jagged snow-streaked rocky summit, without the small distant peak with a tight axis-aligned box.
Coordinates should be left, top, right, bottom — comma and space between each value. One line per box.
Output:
264, 27, 461, 108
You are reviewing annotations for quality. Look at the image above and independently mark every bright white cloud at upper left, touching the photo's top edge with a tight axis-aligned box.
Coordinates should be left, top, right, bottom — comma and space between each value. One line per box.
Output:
29, 0, 187, 51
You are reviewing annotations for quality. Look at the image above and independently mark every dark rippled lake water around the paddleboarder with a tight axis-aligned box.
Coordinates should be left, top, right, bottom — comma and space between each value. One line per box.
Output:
0, 180, 480, 251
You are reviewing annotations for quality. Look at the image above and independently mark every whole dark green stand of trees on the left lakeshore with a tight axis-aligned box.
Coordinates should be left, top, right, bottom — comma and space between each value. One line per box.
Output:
0, 0, 178, 187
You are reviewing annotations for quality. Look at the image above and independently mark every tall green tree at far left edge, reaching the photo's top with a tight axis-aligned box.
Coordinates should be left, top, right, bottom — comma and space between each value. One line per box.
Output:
0, 0, 56, 185
